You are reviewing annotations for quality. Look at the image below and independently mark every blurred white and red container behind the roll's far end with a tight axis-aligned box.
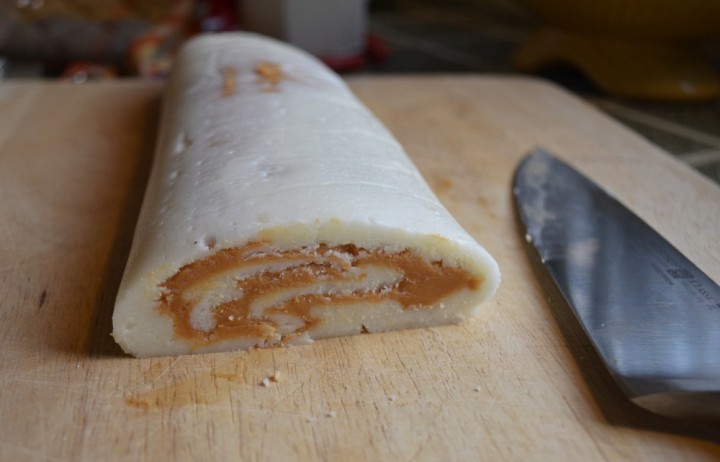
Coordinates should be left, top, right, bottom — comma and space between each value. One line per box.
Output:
238, 0, 367, 58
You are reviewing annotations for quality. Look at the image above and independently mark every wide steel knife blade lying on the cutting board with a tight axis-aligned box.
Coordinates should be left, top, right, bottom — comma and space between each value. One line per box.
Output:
513, 149, 720, 424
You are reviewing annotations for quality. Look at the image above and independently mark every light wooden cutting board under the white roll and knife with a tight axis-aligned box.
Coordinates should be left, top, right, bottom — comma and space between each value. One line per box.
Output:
0, 76, 720, 461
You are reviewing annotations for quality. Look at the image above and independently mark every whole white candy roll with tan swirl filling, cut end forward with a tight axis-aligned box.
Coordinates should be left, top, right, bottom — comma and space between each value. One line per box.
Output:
113, 33, 500, 357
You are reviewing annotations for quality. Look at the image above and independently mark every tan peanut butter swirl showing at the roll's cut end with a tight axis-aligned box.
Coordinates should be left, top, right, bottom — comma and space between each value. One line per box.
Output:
158, 242, 480, 345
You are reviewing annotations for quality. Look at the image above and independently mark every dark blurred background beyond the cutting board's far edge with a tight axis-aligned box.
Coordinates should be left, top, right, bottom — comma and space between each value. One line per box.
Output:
0, 0, 720, 183
